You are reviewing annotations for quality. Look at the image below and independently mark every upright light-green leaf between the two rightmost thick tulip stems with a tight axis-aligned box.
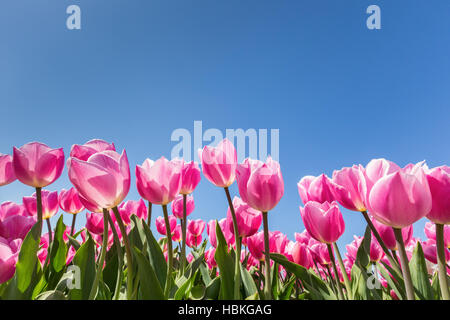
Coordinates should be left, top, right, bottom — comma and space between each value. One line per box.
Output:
409, 242, 435, 300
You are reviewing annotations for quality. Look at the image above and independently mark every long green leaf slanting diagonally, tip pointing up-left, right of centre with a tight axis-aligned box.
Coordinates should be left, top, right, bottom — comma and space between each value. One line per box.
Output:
270, 253, 337, 300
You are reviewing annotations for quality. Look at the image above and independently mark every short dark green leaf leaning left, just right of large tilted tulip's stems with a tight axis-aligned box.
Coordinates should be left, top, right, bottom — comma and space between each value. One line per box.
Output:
133, 247, 166, 300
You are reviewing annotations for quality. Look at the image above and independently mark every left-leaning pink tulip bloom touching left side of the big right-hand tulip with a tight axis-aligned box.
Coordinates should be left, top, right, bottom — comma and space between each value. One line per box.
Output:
332, 165, 367, 212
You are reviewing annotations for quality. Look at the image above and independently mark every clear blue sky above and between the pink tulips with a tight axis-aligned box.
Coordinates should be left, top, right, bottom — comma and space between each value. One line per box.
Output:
0, 0, 450, 250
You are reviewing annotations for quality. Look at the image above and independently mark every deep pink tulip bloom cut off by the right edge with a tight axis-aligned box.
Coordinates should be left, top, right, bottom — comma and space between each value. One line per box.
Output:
427, 166, 450, 225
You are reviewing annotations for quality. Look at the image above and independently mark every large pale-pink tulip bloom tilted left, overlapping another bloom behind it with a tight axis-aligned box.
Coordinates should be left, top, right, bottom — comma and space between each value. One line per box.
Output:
67, 150, 130, 209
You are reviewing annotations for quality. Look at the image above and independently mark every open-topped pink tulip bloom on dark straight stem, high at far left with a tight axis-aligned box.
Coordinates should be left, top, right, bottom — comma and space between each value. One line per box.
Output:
13, 142, 64, 188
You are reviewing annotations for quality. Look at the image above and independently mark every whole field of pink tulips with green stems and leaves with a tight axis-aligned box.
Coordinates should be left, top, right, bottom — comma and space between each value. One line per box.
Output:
0, 139, 450, 300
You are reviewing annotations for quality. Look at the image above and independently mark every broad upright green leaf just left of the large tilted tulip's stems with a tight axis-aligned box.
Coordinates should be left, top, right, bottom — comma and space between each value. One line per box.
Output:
69, 232, 96, 300
